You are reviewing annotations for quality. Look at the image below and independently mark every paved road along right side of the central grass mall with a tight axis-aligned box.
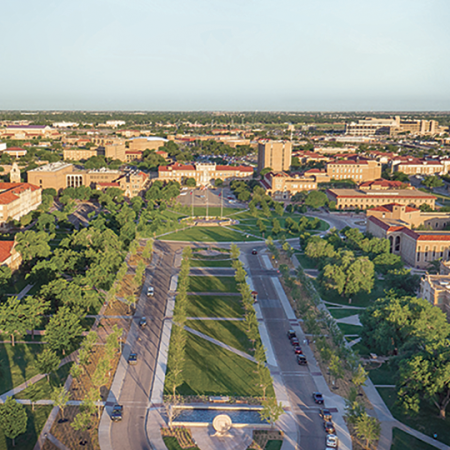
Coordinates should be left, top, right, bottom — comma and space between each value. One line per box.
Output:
241, 246, 326, 450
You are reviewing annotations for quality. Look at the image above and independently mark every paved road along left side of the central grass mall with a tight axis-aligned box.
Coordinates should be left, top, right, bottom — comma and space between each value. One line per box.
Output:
111, 241, 177, 450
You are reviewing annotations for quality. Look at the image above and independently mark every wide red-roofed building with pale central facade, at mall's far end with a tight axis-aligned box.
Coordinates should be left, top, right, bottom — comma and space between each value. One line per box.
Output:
158, 163, 253, 186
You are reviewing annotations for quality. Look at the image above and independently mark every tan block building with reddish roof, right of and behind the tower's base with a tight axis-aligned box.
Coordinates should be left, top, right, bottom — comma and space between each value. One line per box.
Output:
326, 157, 381, 183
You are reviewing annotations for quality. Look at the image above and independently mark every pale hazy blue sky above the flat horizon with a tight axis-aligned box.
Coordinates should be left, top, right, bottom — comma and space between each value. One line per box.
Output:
0, 0, 450, 111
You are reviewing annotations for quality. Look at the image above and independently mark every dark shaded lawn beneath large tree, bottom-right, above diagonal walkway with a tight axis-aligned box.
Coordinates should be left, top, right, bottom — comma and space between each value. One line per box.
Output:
378, 388, 450, 449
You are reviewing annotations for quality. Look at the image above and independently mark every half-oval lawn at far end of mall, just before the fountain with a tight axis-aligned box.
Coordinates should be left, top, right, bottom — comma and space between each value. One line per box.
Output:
160, 227, 260, 242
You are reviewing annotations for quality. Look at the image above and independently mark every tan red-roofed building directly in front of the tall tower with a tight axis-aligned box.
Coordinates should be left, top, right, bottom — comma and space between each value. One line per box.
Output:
261, 172, 317, 200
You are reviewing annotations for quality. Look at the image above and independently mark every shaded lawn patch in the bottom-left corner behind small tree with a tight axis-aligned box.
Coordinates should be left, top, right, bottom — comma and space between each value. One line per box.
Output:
0, 406, 53, 450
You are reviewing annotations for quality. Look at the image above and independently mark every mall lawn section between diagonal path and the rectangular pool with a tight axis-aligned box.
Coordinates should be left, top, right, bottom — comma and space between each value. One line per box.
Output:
165, 333, 274, 397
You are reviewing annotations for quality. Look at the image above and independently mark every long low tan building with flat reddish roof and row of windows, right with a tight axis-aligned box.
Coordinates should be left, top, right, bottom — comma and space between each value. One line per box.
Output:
327, 189, 436, 209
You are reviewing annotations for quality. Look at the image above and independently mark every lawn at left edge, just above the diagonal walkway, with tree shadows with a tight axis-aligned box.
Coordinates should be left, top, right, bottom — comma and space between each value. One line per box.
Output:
0, 344, 43, 394
